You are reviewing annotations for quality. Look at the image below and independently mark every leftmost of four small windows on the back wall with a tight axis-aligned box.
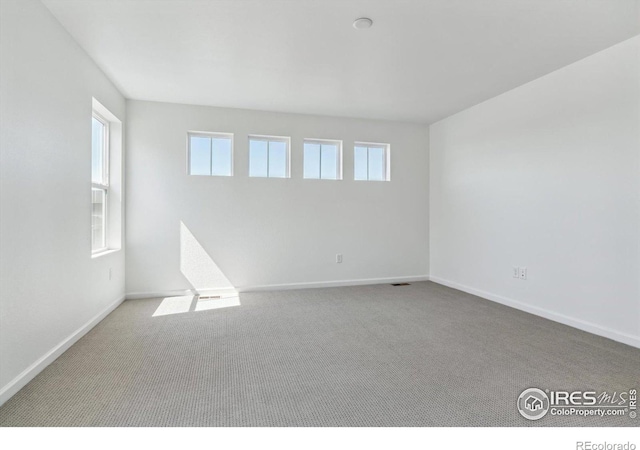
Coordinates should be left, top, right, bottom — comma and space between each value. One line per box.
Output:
188, 133, 233, 177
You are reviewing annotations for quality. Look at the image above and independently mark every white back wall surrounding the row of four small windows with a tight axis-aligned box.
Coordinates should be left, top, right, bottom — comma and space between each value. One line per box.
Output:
127, 101, 428, 296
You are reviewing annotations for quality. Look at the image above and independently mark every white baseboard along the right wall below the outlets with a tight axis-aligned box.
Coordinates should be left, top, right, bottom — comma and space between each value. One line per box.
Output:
429, 276, 640, 348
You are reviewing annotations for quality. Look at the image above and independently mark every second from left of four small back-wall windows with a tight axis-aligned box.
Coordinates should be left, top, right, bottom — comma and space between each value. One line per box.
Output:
249, 136, 290, 178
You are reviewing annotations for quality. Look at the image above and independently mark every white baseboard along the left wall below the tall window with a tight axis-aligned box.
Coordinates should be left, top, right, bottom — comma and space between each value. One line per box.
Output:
0, 296, 124, 405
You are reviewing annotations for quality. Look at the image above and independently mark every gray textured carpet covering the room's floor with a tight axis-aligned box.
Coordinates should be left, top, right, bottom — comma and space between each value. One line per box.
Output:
0, 282, 640, 427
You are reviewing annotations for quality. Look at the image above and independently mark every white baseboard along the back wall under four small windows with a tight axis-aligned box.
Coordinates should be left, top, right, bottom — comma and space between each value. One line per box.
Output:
126, 275, 429, 300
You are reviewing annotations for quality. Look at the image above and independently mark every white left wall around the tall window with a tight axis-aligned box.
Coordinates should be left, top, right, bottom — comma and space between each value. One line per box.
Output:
0, 0, 126, 403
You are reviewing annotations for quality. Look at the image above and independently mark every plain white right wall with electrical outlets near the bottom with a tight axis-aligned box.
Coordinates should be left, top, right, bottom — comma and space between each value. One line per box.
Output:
430, 37, 640, 346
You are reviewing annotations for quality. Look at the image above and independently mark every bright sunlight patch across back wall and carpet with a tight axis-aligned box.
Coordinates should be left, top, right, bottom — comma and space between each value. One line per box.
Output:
153, 221, 240, 317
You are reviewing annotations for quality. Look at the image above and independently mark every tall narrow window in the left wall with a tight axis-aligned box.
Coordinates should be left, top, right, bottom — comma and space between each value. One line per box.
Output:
91, 112, 109, 253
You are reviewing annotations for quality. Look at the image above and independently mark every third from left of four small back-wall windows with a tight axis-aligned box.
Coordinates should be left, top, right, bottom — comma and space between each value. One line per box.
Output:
303, 139, 342, 180
